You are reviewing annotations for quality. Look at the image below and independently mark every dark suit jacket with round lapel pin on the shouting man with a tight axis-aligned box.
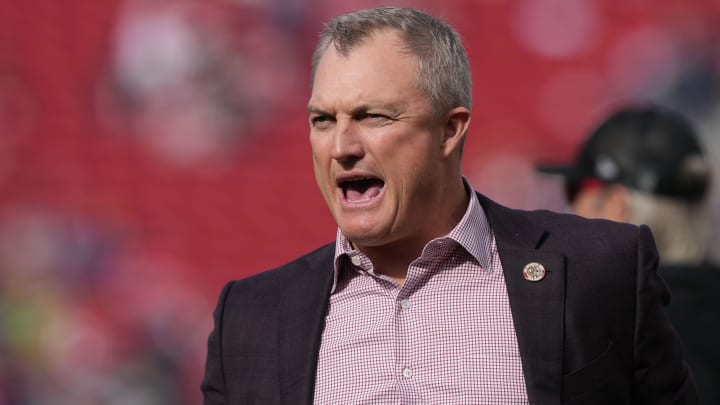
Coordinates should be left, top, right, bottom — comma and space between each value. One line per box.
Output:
202, 195, 698, 405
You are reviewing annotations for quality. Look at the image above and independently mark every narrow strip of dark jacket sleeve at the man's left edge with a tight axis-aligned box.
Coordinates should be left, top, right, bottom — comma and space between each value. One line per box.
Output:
201, 282, 233, 405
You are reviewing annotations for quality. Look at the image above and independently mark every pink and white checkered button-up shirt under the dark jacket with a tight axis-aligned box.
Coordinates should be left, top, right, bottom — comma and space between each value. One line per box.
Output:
315, 184, 528, 405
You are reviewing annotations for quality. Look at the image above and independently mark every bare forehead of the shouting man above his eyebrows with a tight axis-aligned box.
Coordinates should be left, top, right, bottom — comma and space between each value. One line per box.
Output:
311, 30, 417, 107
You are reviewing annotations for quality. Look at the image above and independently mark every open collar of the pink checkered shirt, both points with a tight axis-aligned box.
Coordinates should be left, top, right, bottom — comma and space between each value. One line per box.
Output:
331, 178, 493, 292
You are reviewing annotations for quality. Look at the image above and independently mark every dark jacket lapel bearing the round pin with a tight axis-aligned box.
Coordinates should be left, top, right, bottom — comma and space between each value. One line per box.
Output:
480, 196, 565, 404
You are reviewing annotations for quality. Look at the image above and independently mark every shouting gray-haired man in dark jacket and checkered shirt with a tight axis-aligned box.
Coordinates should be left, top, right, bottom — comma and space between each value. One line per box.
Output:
202, 7, 696, 404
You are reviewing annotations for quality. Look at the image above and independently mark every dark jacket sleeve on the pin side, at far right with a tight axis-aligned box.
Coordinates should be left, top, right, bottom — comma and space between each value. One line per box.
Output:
633, 226, 699, 405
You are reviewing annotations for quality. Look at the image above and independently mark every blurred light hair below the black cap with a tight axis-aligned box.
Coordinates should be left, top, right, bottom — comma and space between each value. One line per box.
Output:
628, 189, 709, 265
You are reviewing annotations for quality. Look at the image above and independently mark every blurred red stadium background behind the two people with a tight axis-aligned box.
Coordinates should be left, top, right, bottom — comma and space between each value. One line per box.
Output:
0, 0, 720, 405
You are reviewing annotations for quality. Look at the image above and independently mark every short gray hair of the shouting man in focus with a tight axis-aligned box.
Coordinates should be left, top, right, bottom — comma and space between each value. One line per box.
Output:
311, 7, 472, 116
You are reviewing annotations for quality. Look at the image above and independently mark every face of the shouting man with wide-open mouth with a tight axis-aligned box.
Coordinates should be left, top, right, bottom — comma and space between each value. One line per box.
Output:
308, 29, 469, 250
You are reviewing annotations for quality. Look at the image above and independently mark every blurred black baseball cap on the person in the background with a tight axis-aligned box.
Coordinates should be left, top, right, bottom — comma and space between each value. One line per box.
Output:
536, 105, 711, 201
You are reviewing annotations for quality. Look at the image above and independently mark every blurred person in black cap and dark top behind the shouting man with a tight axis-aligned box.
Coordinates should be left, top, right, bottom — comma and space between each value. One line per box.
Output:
538, 105, 720, 404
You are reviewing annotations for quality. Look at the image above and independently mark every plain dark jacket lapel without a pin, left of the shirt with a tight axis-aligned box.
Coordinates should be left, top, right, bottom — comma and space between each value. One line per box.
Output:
278, 244, 335, 404
